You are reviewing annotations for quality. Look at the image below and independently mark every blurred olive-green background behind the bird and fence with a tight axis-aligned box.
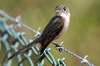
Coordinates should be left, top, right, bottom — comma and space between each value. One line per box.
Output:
0, 0, 100, 66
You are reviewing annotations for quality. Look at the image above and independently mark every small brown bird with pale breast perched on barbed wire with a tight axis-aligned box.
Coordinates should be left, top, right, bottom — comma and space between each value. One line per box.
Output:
8, 5, 70, 60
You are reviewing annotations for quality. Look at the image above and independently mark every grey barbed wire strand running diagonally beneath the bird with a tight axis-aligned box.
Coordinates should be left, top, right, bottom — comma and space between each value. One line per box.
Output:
0, 10, 94, 66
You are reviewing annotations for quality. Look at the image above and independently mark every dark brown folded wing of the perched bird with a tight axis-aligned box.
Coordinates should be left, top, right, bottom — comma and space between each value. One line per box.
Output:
40, 16, 64, 53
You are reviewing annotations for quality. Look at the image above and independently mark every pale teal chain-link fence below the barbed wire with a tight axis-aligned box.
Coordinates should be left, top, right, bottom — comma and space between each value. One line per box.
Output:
0, 18, 66, 66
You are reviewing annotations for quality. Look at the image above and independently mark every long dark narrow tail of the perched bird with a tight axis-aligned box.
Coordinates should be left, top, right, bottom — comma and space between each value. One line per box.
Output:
8, 39, 40, 60
